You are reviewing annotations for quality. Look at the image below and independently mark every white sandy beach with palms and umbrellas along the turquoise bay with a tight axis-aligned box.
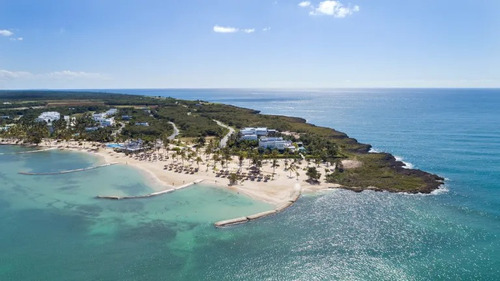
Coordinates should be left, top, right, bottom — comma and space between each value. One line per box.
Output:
0, 139, 346, 206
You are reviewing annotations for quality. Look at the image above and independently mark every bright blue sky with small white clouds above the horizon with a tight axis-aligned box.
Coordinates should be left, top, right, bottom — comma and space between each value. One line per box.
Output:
0, 0, 500, 89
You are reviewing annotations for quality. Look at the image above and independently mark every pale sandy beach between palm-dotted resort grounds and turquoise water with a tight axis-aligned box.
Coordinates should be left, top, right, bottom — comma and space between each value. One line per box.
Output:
0, 139, 339, 207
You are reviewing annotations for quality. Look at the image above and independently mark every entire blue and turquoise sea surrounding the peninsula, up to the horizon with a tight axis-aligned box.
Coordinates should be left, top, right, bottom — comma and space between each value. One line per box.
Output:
0, 89, 500, 280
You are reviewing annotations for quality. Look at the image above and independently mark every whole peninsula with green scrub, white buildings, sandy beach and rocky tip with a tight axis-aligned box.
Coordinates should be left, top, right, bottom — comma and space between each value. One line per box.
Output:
0, 91, 444, 210
